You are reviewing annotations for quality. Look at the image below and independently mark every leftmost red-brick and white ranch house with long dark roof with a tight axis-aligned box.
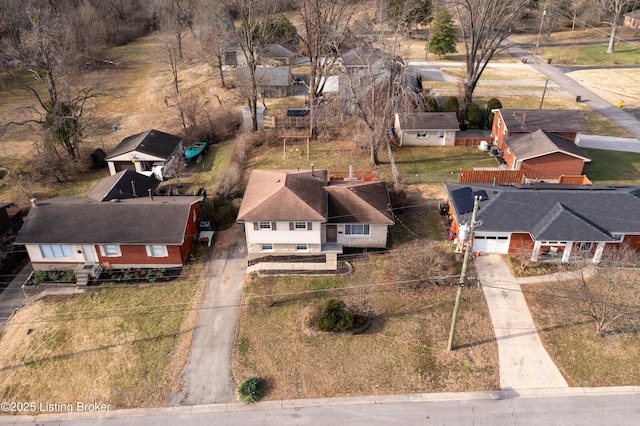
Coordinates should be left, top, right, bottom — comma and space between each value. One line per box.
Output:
15, 171, 203, 280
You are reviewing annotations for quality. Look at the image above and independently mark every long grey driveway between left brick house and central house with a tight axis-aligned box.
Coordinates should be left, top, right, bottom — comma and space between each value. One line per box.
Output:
167, 224, 247, 406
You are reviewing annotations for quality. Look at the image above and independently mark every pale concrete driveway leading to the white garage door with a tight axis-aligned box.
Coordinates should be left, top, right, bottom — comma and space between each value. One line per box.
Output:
475, 254, 568, 390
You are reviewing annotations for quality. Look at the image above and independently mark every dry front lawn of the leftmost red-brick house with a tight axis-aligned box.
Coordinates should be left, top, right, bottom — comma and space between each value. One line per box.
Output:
0, 250, 204, 409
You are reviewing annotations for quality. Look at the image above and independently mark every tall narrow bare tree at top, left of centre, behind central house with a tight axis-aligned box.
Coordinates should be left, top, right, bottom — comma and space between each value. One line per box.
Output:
221, 0, 279, 131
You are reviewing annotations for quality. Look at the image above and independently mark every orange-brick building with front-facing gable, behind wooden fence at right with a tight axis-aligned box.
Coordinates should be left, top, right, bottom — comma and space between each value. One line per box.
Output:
502, 130, 591, 179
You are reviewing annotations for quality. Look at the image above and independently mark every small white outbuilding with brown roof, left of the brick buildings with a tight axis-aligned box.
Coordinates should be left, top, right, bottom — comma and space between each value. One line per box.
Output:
392, 112, 460, 146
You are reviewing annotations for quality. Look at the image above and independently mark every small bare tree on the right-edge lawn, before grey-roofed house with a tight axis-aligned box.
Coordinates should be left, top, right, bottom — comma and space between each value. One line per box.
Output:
554, 246, 640, 337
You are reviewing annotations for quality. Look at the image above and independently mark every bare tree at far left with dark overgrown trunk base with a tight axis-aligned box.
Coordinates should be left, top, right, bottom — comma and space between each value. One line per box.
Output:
2, 8, 105, 162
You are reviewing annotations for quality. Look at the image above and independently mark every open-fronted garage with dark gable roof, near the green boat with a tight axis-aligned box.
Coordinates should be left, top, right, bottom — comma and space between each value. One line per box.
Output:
105, 129, 184, 181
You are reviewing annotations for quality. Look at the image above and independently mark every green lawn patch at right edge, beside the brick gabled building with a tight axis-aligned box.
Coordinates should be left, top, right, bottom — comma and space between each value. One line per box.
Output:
583, 148, 640, 185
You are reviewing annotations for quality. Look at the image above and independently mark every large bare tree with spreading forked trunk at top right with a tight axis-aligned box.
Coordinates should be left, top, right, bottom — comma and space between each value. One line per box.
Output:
450, 0, 529, 103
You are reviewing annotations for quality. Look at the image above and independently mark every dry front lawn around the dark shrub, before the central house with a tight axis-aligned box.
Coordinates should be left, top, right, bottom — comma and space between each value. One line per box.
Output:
233, 236, 499, 400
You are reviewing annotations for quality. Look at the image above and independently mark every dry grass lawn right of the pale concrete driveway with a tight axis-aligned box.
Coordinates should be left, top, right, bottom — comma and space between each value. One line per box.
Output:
523, 283, 640, 387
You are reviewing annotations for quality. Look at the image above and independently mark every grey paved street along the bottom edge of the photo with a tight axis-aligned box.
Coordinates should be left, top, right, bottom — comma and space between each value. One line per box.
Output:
6, 387, 640, 426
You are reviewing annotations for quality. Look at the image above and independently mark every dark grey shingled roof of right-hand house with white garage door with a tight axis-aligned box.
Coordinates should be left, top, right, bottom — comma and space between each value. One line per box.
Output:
445, 183, 640, 241
